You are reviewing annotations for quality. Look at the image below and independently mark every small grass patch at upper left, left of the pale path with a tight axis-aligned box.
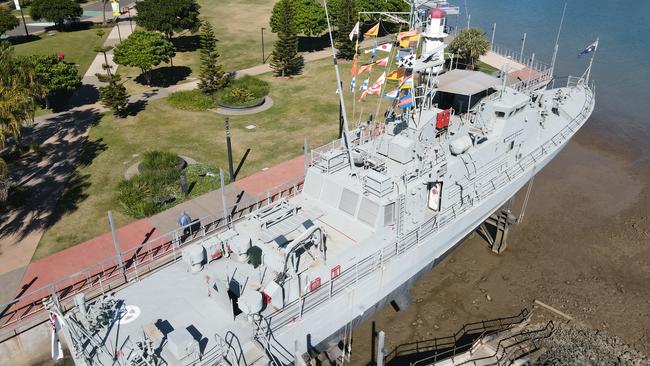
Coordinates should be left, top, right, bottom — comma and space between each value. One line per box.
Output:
14, 29, 109, 75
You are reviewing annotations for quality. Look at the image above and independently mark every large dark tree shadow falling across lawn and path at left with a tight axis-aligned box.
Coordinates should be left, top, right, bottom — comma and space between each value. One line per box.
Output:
0, 110, 107, 242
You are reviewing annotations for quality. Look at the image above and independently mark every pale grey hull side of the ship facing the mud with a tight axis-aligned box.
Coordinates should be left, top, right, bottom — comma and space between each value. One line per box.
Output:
268, 139, 568, 355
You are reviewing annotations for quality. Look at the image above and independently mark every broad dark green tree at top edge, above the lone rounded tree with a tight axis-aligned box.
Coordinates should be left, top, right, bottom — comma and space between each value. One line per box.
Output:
135, 0, 201, 40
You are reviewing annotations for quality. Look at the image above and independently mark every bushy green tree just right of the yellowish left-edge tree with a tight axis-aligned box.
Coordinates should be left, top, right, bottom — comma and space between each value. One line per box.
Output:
29, 55, 81, 107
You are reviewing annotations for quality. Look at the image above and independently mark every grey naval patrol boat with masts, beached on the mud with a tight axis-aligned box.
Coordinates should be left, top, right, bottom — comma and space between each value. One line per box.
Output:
48, 4, 594, 365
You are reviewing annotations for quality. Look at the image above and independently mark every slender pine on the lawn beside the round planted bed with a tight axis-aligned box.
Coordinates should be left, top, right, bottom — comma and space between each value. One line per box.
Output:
199, 20, 227, 94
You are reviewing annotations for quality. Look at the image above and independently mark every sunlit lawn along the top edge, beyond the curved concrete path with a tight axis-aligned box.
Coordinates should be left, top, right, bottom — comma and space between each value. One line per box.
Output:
118, 0, 276, 94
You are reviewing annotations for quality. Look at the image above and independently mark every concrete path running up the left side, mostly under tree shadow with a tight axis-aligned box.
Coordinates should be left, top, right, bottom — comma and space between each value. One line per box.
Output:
0, 9, 131, 304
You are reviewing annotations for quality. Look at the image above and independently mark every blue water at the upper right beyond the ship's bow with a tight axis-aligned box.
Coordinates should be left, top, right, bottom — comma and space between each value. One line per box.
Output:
448, 0, 650, 158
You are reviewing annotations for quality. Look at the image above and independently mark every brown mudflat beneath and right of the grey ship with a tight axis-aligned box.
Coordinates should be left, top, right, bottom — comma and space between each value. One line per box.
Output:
351, 121, 650, 365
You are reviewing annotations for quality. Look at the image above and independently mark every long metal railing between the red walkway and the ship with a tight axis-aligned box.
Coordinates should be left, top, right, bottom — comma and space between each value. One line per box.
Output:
0, 177, 304, 342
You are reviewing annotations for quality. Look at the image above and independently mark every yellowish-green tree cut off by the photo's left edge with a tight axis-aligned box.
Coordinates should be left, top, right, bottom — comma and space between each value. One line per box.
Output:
0, 42, 44, 202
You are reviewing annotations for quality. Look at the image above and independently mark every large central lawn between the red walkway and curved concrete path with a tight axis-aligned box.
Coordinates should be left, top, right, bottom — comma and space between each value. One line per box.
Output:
35, 59, 350, 258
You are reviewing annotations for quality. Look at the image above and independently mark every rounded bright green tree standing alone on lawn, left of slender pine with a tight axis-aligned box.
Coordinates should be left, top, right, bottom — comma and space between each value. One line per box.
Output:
113, 31, 176, 84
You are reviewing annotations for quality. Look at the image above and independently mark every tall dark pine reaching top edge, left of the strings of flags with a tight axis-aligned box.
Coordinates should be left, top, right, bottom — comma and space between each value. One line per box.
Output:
270, 0, 303, 76
